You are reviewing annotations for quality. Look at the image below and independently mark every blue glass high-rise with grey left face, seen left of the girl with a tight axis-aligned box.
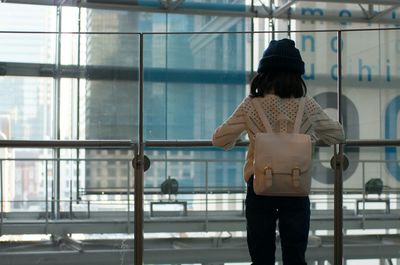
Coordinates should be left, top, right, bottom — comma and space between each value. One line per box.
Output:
85, 7, 248, 198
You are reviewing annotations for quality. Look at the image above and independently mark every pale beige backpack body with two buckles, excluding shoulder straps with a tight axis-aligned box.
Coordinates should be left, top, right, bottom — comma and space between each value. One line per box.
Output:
254, 133, 312, 196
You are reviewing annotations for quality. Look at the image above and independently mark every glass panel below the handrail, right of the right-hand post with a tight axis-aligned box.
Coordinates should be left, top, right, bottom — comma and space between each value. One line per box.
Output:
343, 147, 400, 265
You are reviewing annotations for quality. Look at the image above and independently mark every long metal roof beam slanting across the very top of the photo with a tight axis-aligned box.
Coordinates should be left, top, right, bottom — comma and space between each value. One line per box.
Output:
2, 0, 400, 25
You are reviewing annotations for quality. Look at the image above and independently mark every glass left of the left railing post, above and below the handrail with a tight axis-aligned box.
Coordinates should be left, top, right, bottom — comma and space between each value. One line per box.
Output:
0, 28, 139, 264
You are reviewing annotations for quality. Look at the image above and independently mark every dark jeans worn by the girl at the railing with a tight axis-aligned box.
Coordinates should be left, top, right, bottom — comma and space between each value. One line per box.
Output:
246, 177, 310, 265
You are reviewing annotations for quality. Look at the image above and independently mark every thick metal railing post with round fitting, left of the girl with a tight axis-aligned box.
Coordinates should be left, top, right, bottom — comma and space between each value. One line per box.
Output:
134, 33, 144, 265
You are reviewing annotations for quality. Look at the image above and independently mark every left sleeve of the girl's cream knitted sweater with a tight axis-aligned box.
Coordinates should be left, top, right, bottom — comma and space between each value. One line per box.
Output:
212, 99, 246, 150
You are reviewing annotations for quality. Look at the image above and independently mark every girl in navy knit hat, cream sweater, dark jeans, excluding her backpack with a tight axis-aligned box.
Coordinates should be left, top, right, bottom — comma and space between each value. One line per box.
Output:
212, 39, 344, 265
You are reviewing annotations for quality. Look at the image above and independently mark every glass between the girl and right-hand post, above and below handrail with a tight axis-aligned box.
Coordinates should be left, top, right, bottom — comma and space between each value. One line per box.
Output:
293, 31, 337, 264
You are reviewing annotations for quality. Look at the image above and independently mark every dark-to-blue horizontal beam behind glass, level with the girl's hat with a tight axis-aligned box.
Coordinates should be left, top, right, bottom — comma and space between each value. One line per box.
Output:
4, 61, 400, 91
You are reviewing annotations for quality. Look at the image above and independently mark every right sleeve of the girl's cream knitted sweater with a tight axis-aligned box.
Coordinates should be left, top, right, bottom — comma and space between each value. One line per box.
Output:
308, 98, 345, 145
